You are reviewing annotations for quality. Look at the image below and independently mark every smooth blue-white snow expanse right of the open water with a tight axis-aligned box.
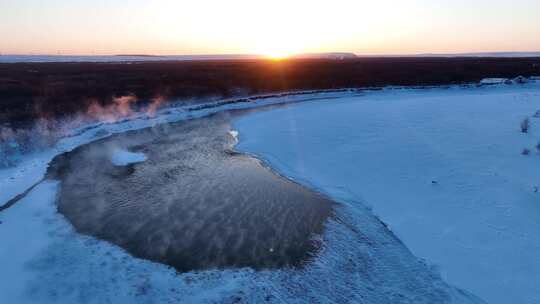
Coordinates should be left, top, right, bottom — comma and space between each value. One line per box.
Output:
233, 83, 540, 304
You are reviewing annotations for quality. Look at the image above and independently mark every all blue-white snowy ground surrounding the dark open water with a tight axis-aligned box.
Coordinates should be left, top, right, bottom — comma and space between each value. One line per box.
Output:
0, 83, 540, 303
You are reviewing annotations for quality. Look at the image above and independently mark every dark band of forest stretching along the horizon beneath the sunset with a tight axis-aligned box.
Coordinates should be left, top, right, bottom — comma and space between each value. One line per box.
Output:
0, 58, 540, 127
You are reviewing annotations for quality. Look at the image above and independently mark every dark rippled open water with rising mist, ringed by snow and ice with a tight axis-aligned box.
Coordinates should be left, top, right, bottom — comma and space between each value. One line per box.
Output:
49, 114, 334, 272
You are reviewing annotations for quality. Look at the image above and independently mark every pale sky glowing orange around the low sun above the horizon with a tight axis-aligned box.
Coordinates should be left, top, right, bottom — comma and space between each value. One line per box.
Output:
0, 0, 540, 57
